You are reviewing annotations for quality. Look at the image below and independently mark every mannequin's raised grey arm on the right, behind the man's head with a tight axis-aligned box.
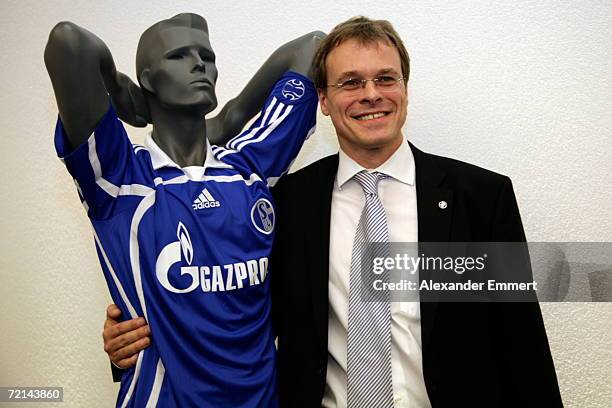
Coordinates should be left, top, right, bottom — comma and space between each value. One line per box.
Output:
206, 31, 325, 145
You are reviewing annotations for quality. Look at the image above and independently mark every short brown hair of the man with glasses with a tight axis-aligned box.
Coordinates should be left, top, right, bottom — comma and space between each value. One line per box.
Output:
313, 16, 410, 89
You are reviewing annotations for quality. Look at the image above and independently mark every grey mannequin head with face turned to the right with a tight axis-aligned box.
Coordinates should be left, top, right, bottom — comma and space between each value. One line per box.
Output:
136, 13, 217, 114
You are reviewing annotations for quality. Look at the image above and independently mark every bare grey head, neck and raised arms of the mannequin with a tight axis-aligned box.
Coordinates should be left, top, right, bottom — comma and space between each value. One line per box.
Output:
44, 14, 325, 159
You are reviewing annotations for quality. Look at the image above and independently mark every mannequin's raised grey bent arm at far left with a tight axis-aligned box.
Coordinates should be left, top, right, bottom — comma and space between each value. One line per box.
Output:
45, 22, 147, 148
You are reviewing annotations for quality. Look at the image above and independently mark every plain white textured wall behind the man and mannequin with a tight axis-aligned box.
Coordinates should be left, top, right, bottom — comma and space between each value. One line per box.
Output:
0, 0, 612, 407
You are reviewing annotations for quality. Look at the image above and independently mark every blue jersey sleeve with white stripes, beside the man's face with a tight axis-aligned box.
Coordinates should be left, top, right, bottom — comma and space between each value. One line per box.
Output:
212, 72, 318, 185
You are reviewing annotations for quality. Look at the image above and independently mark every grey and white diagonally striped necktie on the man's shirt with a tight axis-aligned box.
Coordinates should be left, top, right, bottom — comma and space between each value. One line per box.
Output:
347, 171, 393, 408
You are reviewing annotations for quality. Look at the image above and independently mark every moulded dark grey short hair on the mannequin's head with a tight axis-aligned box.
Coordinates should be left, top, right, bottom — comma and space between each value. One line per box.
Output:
136, 13, 208, 80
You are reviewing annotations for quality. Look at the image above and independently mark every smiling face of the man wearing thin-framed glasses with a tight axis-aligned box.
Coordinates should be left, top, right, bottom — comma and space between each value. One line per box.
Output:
317, 38, 408, 169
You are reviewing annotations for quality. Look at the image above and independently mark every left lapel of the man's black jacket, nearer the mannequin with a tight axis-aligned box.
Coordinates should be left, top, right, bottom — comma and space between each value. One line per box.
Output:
309, 154, 338, 353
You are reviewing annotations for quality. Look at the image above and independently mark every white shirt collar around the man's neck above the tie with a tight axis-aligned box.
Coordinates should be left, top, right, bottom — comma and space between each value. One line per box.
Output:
336, 140, 415, 189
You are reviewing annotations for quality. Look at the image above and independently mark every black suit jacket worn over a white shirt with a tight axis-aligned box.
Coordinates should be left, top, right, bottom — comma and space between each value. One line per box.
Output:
270, 145, 562, 408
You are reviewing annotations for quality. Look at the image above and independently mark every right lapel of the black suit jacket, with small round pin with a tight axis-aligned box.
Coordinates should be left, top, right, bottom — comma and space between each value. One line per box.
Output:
409, 143, 453, 347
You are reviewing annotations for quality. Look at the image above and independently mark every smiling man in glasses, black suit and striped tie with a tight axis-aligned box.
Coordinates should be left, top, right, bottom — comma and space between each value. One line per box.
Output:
270, 17, 562, 408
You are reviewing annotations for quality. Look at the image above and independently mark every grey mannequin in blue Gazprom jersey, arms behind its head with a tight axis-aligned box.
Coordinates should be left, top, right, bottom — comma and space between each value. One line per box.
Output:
45, 14, 324, 407
